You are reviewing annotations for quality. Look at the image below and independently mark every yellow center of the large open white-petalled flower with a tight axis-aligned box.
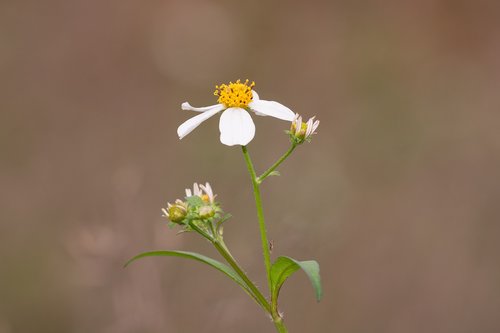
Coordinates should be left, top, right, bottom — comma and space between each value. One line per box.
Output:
214, 80, 255, 108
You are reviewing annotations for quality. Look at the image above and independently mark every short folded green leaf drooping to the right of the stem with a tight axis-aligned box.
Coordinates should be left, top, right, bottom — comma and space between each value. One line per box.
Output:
271, 257, 323, 302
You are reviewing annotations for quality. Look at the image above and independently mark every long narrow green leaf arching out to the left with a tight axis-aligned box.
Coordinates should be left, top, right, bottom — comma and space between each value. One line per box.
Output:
124, 251, 254, 297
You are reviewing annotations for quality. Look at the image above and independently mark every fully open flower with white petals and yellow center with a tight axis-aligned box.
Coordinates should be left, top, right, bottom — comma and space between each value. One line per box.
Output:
177, 80, 294, 146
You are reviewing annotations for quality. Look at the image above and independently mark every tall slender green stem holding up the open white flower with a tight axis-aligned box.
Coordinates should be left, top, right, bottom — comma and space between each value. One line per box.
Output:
241, 146, 272, 291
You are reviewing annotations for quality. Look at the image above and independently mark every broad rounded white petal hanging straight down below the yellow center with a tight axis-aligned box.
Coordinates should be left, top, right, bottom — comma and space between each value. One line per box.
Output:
219, 108, 255, 146
